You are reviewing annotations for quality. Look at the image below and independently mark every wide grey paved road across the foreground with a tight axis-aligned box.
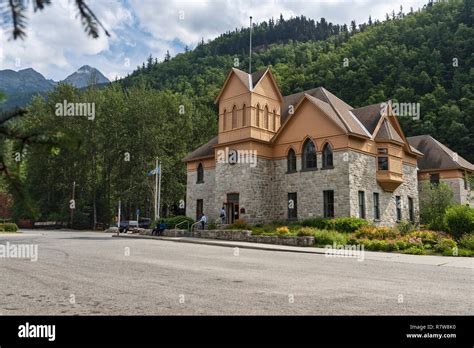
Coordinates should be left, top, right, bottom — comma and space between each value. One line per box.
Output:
0, 231, 474, 315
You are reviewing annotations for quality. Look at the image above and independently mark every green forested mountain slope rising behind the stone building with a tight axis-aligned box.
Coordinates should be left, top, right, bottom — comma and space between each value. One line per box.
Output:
121, 0, 474, 162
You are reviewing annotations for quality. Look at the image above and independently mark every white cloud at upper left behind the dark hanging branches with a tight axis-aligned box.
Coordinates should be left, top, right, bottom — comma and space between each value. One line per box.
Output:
0, 0, 131, 79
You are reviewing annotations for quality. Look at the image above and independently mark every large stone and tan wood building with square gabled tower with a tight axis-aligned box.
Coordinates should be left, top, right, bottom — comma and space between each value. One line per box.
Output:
183, 68, 472, 225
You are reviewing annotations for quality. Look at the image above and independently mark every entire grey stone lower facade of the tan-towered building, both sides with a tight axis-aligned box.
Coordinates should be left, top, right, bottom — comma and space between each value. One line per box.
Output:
186, 150, 419, 226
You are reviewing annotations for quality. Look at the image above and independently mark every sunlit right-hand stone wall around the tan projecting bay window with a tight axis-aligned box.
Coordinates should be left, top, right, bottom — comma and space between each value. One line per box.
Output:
349, 151, 419, 226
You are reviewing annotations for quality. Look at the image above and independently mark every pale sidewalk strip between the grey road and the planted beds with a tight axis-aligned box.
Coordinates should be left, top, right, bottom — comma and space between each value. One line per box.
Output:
112, 234, 474, 269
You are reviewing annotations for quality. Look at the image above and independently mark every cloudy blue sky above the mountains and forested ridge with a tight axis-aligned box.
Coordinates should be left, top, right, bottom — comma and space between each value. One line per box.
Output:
0, 0, 427, 81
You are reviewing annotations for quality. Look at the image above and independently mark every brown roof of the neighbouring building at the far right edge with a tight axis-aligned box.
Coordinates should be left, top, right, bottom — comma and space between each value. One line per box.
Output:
407, 134, 474, 171
